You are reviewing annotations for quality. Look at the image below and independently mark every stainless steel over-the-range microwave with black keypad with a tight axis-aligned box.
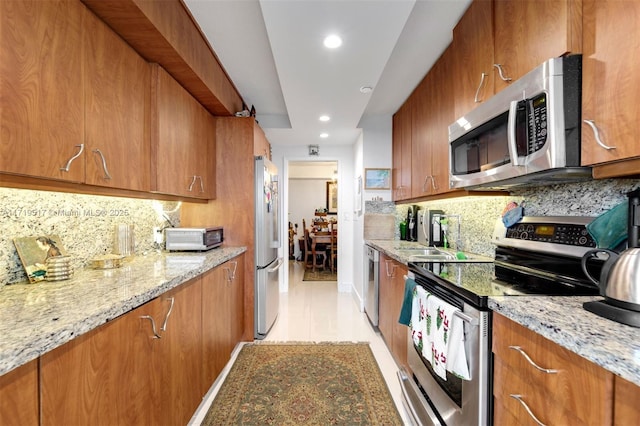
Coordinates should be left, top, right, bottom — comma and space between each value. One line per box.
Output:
449, 55, 591, 190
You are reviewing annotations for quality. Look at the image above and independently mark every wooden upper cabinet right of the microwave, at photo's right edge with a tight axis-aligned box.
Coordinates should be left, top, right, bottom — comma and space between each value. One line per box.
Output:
582, 0, 640, 177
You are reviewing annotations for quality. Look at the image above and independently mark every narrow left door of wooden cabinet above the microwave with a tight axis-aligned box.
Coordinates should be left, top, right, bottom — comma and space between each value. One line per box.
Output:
452, 0, 494, 119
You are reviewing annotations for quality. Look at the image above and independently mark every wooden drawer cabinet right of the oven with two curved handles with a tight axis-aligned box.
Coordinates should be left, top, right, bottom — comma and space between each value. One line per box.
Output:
493, 313, 614, 426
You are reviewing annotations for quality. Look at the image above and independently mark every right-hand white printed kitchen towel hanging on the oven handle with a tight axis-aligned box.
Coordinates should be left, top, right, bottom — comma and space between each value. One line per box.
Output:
423, 295, 470, 380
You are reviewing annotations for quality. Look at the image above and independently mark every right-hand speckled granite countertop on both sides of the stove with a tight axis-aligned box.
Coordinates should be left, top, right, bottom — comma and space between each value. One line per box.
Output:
365, 240, 640, 386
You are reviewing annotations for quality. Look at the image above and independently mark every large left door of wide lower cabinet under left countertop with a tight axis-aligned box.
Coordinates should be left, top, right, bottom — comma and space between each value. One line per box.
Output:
40, 299, 165, 425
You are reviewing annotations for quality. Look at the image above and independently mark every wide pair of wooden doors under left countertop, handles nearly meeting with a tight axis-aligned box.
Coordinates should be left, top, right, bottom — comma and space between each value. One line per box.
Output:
40, 278, 203, 425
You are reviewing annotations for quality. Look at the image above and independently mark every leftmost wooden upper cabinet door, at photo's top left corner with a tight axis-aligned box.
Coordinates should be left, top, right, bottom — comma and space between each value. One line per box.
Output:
0, 0, 88, 182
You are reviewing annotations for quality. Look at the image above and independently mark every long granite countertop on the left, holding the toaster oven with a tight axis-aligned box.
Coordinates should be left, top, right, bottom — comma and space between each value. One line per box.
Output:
0, 247, 246, 375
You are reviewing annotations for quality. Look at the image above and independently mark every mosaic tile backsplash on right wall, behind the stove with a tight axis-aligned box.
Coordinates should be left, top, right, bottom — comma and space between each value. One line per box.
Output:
382, 179, 640, 257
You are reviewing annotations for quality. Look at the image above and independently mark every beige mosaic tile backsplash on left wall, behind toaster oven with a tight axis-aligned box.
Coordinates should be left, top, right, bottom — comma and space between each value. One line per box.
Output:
0, 188, 180, 287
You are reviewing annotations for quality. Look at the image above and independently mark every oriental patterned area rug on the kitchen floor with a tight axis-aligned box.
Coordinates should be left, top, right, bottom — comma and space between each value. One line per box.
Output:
202, 342, 402, 426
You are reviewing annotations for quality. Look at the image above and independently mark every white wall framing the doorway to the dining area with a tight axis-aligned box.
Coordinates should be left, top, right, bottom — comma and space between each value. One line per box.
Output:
272, 142, 358, 292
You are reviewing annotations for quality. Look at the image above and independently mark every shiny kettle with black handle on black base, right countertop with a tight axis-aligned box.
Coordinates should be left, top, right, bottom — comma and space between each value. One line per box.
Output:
582, 189, 640, 327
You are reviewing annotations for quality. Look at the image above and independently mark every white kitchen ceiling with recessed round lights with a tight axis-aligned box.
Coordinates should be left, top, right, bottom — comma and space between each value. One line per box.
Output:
184, 0, 471, 146
